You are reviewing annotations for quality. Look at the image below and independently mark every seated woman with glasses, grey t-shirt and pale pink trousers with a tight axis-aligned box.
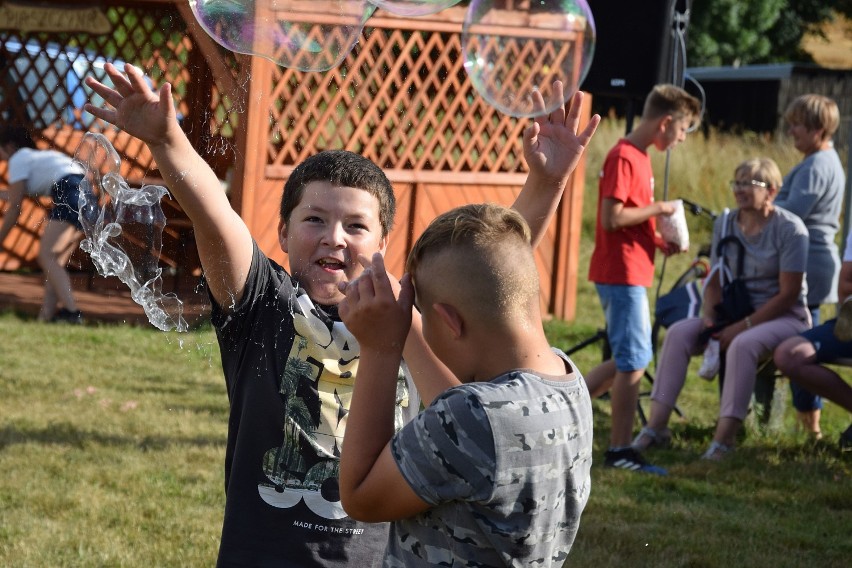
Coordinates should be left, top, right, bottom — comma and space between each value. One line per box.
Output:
633, 158, 810, 460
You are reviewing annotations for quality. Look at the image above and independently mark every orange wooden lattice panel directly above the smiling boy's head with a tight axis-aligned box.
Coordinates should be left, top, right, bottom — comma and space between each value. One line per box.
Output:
267, 12, 527, 173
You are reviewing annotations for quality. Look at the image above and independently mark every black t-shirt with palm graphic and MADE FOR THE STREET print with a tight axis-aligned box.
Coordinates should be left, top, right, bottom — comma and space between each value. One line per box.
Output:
212, 245, 419, 568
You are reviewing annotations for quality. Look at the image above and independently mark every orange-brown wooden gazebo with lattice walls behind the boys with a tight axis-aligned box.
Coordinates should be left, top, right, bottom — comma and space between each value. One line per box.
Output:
0, 0, 589, 320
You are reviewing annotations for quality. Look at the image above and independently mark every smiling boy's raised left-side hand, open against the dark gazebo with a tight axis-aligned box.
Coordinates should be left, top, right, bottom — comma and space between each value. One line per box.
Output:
83, 63, 180, 146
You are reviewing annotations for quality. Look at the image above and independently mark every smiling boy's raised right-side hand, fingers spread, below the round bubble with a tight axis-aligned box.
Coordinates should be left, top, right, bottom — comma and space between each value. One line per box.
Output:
523, 81, 601, 187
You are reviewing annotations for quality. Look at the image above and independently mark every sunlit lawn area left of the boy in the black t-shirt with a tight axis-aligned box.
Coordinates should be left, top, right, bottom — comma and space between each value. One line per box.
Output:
0, 314, 227, 567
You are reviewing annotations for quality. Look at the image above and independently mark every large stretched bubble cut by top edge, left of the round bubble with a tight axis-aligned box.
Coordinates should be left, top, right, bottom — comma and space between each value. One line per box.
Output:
189, 0, 376, 71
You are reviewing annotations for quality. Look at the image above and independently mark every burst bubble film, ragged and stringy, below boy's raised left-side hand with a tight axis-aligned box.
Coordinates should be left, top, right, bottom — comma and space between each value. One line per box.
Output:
74, 132, 189, 331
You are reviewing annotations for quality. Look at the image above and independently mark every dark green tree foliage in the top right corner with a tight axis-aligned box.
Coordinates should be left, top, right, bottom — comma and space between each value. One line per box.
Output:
687, 0, 852, 67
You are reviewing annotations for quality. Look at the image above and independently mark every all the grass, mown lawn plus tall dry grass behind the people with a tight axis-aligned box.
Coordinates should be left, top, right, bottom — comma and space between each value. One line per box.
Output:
0, 120, 852, 568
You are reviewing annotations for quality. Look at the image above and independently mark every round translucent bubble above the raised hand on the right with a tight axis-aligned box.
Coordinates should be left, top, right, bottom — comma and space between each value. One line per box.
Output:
462, 0, 595, 117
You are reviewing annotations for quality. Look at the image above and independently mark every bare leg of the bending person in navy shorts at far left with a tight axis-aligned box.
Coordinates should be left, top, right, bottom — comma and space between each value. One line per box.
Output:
38, 219, 80, 320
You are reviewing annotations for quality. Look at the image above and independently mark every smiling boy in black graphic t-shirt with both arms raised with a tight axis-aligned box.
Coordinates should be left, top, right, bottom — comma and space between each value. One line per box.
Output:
86, 64, 596, 567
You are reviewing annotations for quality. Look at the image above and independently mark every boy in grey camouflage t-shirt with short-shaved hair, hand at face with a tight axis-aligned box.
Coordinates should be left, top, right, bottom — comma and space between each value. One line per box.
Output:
340, 205, 592, 568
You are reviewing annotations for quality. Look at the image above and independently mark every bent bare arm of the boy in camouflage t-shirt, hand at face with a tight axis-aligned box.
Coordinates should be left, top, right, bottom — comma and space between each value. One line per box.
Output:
340, 253, 429, 522
